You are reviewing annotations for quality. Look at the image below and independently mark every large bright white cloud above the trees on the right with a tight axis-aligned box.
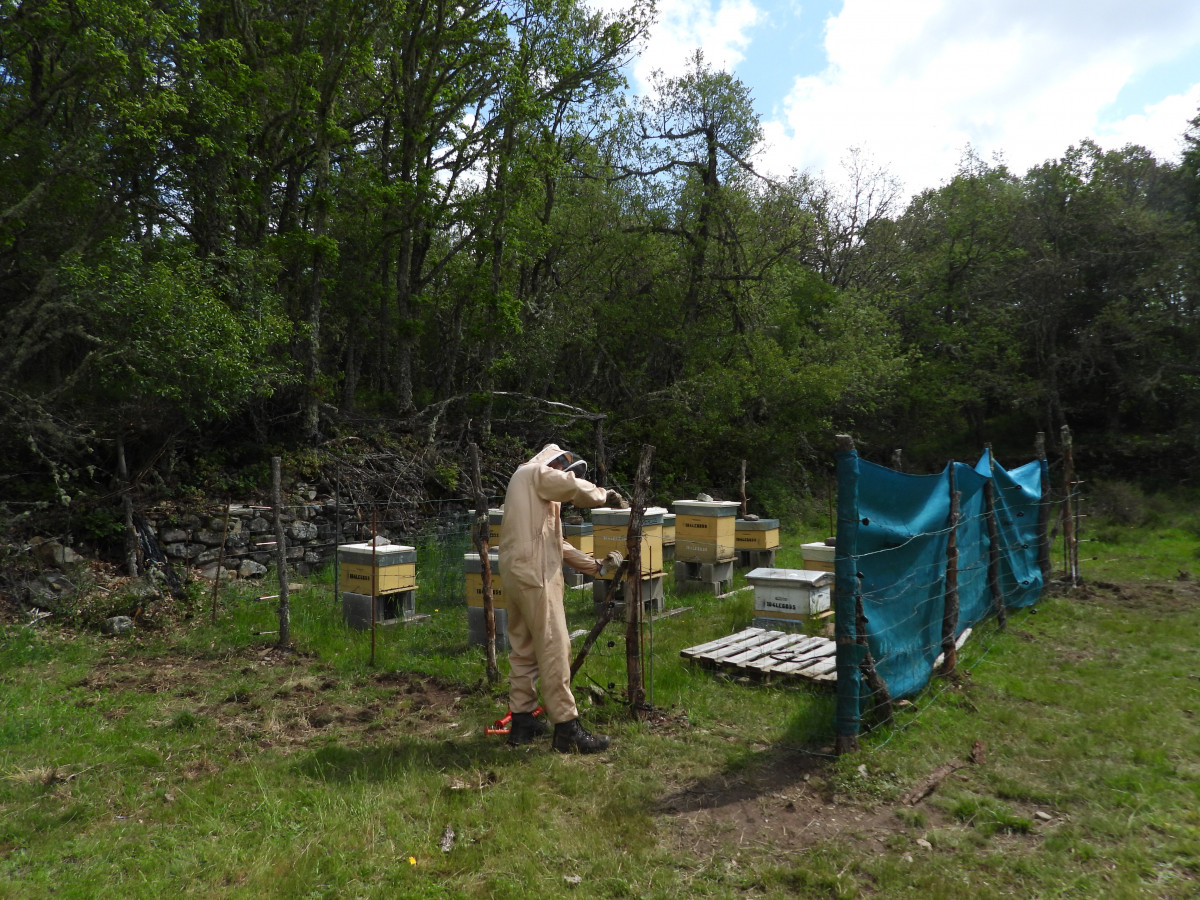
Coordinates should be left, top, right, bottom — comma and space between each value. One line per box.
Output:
764, 0, 1200, 191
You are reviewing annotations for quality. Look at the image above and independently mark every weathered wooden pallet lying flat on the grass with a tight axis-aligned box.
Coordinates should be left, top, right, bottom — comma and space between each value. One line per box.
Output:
679, 628, 838, 684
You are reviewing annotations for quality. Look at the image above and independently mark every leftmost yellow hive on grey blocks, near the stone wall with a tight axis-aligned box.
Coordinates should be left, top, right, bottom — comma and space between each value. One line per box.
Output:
337, 538, 416, 629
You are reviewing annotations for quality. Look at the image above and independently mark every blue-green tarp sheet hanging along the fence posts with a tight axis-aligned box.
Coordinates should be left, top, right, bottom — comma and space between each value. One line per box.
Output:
835, 450, 1045, 734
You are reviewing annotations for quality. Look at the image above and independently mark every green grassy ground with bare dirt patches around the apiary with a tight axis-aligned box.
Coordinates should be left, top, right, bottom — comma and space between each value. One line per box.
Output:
0, 509, 1200, 900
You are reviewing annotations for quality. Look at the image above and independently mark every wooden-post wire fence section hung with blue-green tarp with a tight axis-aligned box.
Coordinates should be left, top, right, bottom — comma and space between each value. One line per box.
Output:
834, 432, 1081, 750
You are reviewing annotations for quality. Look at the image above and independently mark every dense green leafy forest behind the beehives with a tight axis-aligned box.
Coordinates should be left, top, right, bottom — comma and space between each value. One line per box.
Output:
0, 0, 1200, 536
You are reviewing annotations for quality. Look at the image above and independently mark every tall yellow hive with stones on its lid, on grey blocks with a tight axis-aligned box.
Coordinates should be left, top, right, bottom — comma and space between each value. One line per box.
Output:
674, 500, 740, 594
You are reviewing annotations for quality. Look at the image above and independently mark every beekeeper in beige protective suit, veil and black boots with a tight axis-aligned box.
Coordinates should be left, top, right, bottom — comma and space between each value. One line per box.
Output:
500, 444, 629, 754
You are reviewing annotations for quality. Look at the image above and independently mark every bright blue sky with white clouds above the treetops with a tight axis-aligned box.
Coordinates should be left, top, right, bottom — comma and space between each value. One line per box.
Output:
593, 0, 1200, 196
